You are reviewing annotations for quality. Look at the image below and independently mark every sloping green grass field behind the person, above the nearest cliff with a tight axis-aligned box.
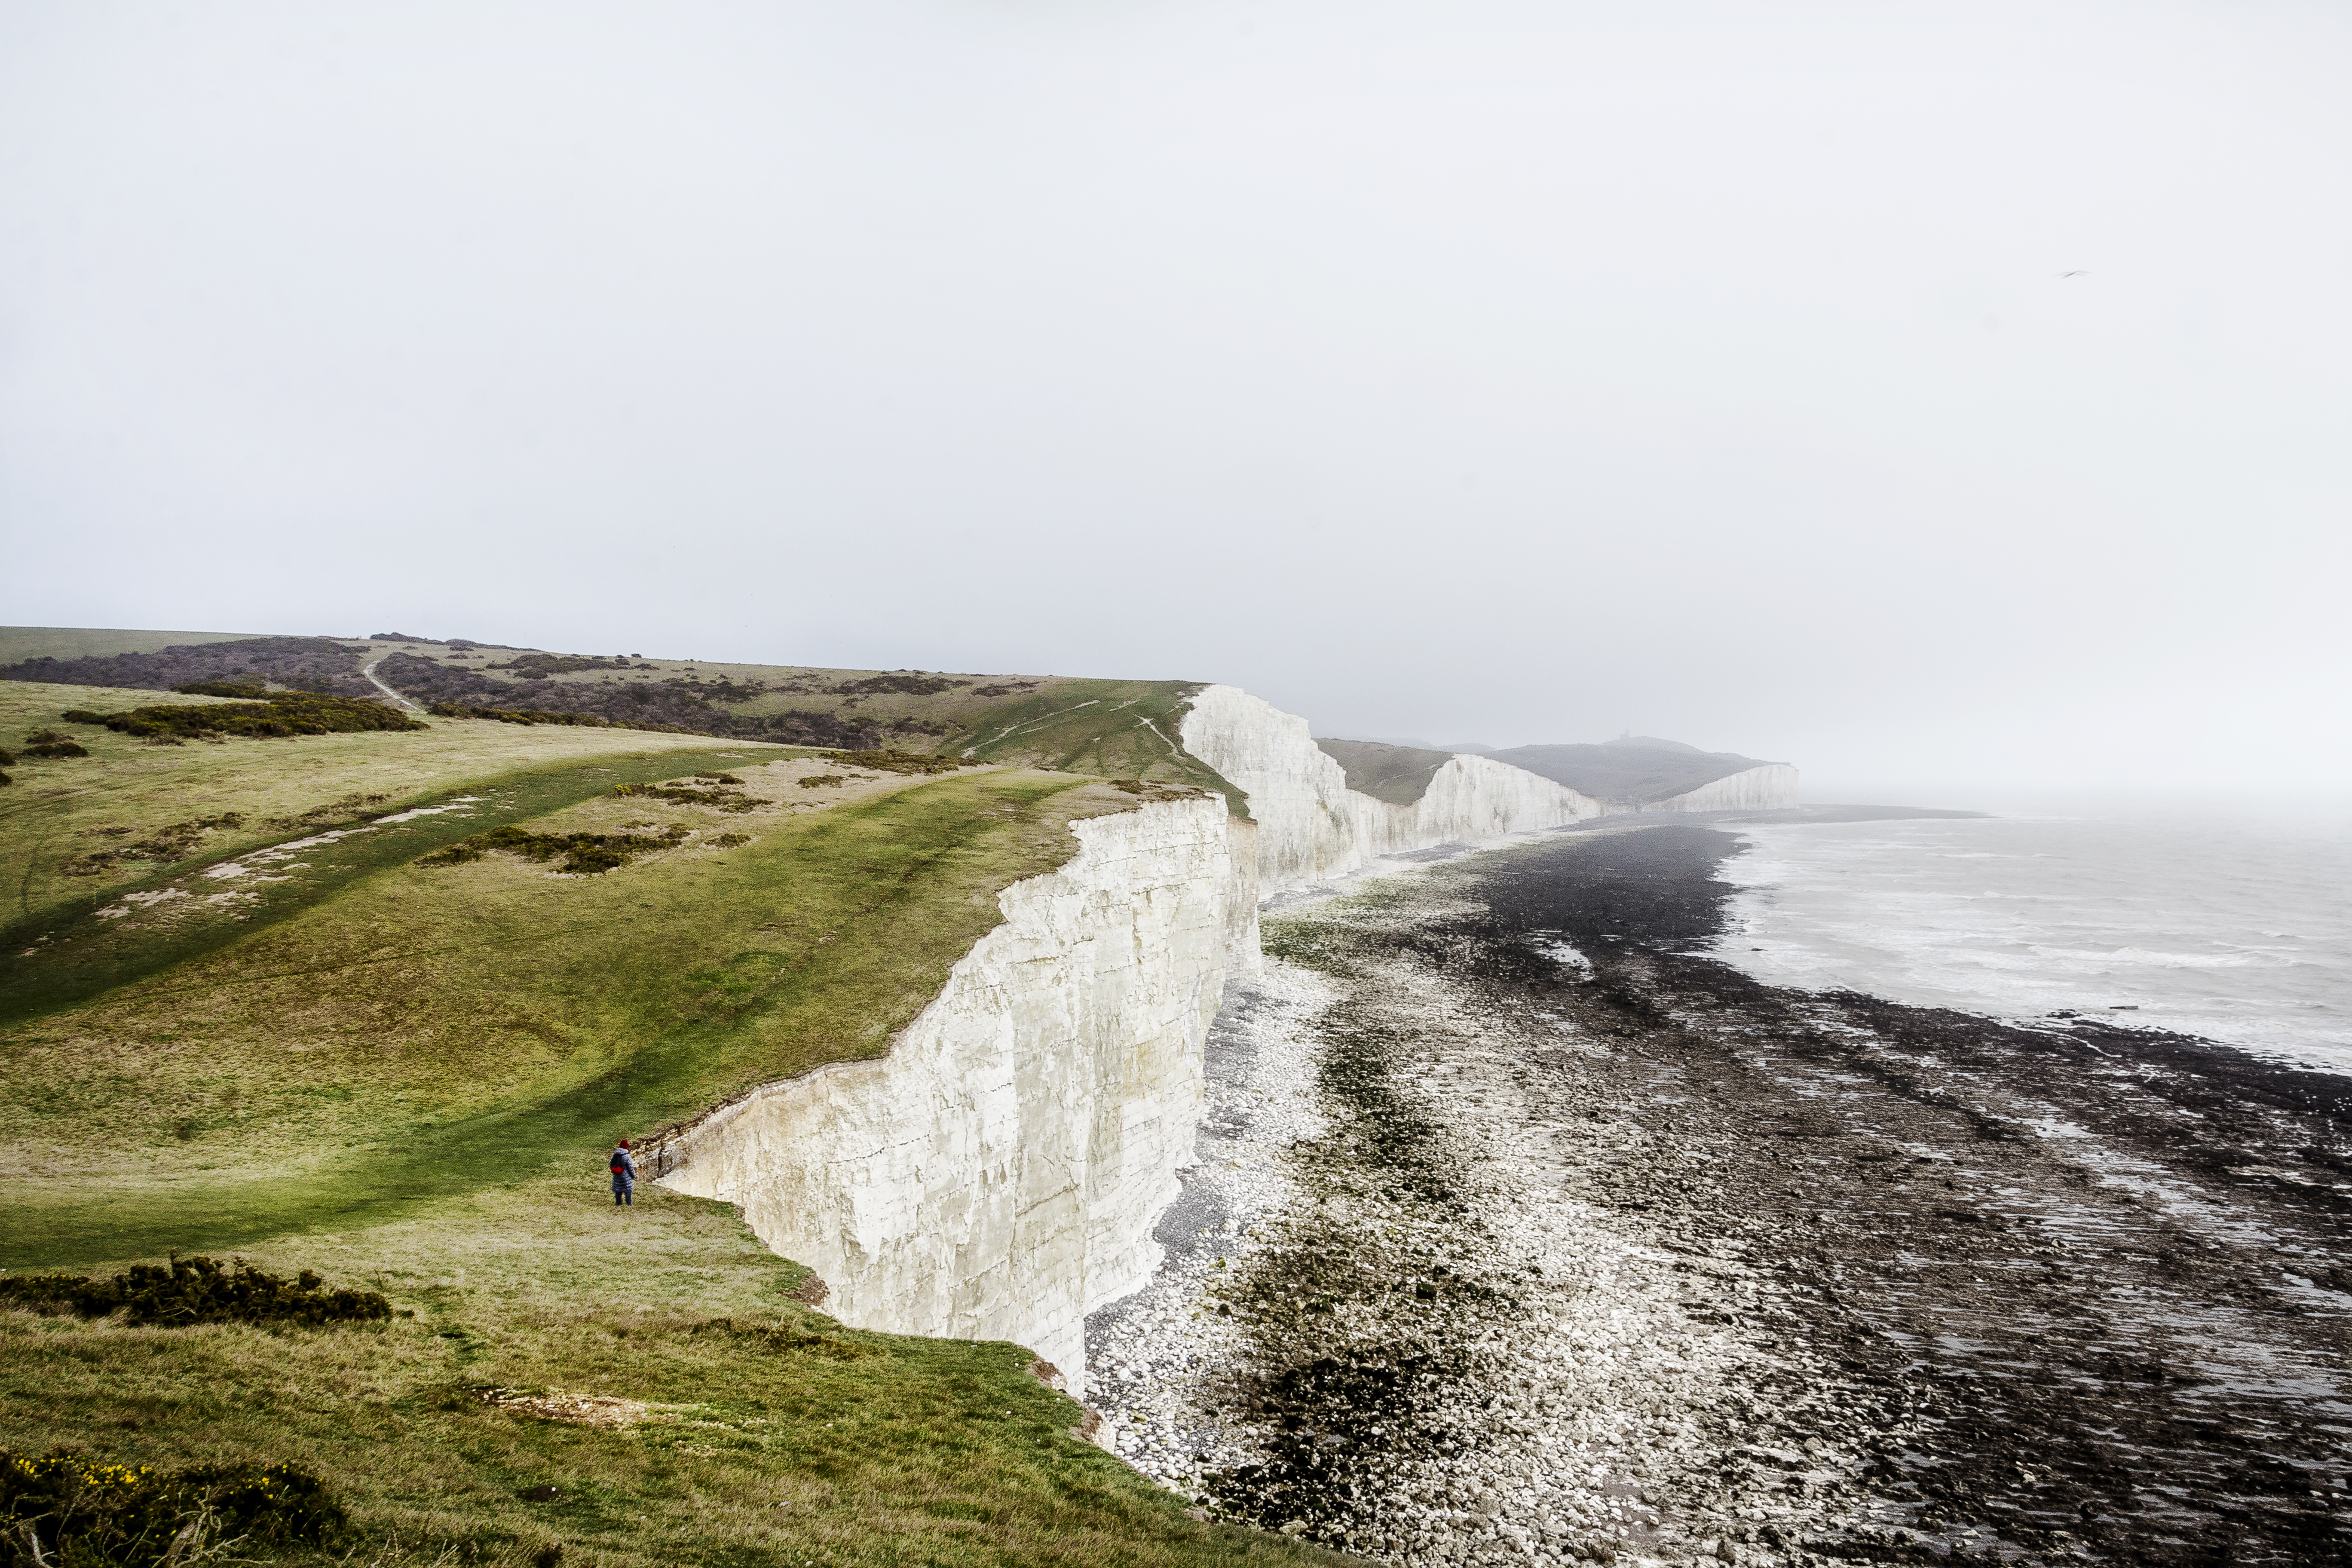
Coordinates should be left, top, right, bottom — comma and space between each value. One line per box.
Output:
0, 762, 1148, 1267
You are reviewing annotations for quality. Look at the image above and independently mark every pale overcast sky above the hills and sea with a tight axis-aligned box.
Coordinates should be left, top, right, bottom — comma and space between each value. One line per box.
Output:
0, 0, 2352, 804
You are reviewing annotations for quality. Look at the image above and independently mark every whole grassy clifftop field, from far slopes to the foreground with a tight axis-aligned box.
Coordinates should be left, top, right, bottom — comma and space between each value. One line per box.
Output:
0, 644, 1315, 1566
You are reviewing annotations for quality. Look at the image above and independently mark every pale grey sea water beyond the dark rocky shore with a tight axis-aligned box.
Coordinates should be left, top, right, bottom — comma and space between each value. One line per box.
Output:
1717, 804, 2352, 1074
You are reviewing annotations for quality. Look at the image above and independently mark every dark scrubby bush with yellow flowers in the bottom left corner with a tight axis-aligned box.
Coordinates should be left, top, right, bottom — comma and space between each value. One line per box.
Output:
0, 1448, 350, 1568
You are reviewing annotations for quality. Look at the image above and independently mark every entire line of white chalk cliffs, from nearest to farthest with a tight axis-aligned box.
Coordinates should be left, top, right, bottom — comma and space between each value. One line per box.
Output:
649, 686, 1797, 1396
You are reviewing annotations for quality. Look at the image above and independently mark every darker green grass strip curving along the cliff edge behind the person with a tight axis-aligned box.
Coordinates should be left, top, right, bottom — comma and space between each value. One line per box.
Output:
14, 762, 1091, 1269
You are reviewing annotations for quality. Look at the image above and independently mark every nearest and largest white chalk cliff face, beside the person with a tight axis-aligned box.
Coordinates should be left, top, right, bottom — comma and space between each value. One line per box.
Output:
656, 797, 1256, 1394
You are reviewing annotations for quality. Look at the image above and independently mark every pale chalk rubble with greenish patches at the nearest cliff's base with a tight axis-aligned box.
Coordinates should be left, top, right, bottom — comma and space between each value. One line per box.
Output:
1089, 915, 1910, 1563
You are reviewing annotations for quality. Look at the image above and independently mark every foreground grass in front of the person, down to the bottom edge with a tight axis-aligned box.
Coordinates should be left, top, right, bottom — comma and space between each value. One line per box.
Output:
0, 1173, 1338, 1568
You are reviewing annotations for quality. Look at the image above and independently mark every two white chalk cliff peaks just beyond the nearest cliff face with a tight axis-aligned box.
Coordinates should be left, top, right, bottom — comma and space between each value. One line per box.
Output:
1181, 686, 1602, 893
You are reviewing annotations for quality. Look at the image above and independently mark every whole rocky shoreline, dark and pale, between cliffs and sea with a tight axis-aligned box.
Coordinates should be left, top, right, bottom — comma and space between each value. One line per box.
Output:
1089, 825, 2352, 1563
